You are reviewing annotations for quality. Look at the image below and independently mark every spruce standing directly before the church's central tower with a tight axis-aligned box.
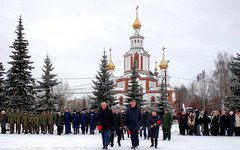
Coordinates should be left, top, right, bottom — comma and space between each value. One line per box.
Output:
126, 62, 143, 106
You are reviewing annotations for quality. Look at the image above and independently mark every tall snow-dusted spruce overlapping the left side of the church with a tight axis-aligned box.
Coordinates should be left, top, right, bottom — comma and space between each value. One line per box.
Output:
92, 51, 115, 109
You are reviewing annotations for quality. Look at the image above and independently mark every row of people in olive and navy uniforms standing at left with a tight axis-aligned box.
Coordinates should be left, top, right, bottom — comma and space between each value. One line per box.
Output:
0, 108, 96, 135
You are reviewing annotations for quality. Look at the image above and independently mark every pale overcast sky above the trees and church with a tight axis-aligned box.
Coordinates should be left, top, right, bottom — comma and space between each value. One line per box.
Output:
0, 0, 240, 98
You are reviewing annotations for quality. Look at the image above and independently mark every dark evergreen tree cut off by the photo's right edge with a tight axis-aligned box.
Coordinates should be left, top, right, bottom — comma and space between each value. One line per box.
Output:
229, 54, 240, 109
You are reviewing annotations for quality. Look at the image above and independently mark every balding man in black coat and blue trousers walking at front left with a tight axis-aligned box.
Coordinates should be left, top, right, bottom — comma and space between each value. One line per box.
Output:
97, 102, 114, 150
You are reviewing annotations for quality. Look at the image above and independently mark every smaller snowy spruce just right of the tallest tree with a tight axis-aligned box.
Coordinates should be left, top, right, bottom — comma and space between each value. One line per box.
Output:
37, 55, 59, 111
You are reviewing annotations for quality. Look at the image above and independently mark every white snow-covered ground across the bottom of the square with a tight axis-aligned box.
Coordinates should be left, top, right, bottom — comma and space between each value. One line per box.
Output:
0, 124, 240, 150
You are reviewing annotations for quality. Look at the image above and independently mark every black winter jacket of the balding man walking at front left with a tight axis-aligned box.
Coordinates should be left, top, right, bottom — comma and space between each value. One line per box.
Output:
97, 107, 114, 130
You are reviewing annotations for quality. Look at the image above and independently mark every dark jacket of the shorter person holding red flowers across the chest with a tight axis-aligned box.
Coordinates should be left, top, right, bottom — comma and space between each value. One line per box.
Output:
146, 116, 161, 138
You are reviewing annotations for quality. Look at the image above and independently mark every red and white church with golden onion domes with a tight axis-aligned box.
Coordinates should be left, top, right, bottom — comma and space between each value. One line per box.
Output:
108, 7, 176, 108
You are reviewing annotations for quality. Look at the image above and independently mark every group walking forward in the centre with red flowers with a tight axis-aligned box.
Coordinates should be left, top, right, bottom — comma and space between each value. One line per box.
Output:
97, 100, 173, 150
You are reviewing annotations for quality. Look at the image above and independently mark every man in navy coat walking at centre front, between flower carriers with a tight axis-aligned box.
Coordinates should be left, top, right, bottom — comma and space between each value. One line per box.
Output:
124, 100, 143, 149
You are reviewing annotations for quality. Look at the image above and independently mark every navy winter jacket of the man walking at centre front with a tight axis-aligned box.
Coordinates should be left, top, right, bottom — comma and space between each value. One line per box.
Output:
124, 107, 143, 131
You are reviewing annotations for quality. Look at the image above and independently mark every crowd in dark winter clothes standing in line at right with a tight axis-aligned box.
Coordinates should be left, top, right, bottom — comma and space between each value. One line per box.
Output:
177, 109, 240, 136
